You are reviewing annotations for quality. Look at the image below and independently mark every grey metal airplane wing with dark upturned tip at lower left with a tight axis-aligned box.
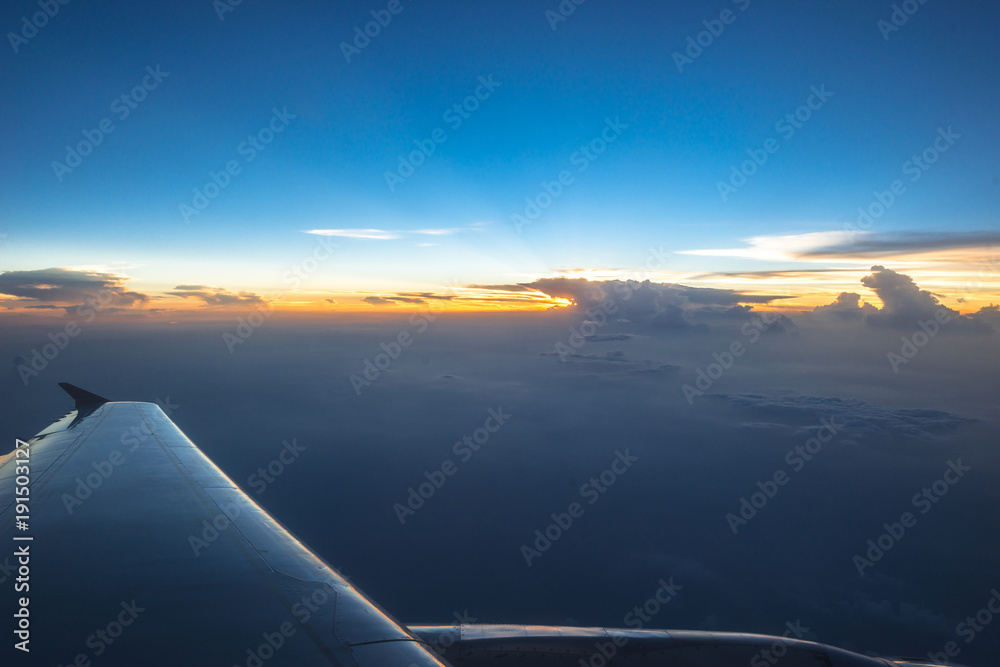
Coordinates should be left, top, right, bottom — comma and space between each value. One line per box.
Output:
0, 385, 446, 667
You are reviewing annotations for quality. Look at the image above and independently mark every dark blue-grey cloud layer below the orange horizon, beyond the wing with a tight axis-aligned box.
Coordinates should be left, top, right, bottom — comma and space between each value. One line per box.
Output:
0, 268, 1000, 665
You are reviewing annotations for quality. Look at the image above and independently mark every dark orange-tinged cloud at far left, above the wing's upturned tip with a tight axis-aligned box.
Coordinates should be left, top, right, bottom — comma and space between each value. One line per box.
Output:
0, 268, 149, 312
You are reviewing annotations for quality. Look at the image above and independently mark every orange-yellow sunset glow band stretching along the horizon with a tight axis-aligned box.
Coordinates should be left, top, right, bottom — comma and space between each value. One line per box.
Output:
0, 268, 1000, 322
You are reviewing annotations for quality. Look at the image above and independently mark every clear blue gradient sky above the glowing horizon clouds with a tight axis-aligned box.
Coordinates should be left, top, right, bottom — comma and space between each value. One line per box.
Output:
0, 0, 1000, 306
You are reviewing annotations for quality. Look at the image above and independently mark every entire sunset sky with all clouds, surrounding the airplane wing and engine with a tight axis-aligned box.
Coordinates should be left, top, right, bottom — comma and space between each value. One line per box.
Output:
0, 0, 1000, 666
